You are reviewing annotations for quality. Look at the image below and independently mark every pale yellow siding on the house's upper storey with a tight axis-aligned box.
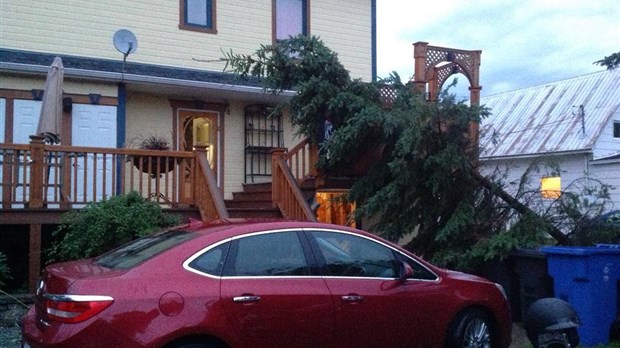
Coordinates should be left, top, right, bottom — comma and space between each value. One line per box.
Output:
0, 0, 371, 79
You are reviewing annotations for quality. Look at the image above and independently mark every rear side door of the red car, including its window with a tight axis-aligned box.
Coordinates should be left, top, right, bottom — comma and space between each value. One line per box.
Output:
221, 230, 334, 348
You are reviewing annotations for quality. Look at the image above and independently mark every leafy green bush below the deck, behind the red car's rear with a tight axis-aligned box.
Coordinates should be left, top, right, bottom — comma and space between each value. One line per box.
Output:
49, 192, 179, 261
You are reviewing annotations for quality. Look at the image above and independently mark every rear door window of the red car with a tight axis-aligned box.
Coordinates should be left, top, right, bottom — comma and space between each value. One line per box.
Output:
227, 232, 310, 276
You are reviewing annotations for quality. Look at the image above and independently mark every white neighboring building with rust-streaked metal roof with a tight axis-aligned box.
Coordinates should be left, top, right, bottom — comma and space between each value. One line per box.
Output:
480, 69, 620, 209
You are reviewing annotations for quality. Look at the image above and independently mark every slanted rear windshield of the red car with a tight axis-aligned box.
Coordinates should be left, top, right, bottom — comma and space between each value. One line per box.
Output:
95, 230, 198, 269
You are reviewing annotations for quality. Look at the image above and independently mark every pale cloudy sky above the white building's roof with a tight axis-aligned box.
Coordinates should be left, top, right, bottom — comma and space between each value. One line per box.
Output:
377, 0, 620, 98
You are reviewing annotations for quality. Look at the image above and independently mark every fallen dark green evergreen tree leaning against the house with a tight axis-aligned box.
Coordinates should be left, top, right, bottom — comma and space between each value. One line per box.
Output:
224, 36, 608, 271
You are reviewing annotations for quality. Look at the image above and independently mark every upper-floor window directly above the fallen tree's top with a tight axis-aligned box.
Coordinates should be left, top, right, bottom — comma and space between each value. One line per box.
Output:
273, 0, 310, 40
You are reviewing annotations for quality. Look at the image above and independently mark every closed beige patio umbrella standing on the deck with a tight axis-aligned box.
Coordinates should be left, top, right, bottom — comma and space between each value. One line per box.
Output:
37, 57, 64, 144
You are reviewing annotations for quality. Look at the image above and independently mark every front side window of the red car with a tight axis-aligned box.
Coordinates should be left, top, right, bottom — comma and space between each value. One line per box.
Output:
312, 231, 398, 278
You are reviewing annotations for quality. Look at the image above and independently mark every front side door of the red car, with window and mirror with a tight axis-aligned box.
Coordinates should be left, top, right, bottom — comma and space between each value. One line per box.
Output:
309, 231, 445, 348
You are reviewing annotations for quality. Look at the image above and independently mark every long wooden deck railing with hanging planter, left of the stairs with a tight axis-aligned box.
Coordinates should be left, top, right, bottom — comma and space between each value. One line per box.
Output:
0, 136, 222, 218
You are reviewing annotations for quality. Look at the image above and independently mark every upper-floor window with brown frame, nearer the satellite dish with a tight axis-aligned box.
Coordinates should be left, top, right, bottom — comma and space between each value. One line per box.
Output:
179, 0, 217, 33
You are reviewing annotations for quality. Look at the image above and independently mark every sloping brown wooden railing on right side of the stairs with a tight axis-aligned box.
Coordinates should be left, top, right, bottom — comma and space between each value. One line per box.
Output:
271, 149, 316, 221
